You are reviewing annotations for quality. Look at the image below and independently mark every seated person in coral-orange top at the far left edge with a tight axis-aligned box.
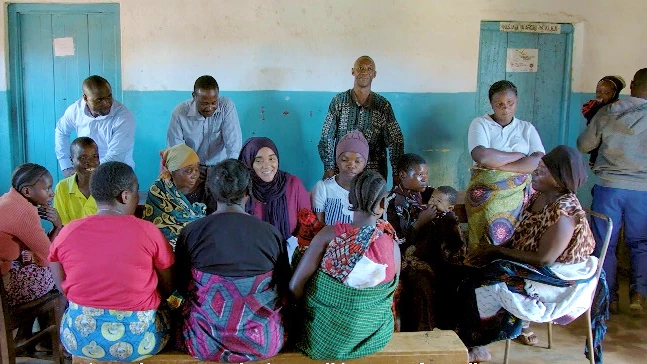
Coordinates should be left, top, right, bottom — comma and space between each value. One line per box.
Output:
0, 163, 63, 340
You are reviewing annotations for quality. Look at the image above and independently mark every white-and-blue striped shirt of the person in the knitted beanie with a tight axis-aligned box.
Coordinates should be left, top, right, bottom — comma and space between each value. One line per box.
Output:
312, 176, 353, 225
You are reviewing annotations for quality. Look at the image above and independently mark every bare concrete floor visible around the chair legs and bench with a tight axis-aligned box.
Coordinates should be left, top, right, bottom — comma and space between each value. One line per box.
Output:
12, 282, 647, 364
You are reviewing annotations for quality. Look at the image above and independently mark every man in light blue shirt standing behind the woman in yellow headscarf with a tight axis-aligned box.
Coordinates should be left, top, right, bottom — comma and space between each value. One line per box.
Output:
166, 76, 243, 211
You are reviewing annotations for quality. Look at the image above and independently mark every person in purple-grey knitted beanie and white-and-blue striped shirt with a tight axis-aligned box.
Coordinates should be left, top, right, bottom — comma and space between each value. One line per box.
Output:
312, 130, 368, 225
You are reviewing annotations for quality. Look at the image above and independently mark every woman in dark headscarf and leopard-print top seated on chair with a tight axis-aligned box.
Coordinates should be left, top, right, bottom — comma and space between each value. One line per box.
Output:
457, 145, 608, 362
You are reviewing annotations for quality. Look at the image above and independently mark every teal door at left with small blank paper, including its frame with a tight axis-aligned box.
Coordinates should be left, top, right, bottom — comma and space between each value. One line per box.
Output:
9, 4, 121, 182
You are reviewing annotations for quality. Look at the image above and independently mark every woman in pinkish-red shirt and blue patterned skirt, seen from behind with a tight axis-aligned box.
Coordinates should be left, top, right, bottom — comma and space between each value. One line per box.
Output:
49, 162, 174, 361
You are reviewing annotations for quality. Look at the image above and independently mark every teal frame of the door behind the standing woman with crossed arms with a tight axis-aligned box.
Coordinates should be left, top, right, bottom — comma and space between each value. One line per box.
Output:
474, 20, 575, 144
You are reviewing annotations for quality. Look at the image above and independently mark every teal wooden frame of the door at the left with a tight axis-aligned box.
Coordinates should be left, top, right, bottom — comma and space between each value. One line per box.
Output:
7, 4, 122, 169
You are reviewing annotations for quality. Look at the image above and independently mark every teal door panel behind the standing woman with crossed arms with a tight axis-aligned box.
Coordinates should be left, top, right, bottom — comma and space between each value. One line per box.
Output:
476, 22, 573, 151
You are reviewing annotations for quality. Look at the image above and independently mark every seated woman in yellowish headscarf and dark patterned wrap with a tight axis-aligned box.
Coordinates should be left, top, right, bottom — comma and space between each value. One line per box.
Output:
144, 144, 206, 249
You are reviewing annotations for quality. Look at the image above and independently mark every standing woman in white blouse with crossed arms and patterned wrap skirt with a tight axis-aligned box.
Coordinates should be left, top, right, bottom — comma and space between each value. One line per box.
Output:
465, 81, 545, 246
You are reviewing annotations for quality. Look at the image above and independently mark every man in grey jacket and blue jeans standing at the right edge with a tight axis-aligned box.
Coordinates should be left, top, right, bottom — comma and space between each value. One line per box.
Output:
577, 68, 647, 315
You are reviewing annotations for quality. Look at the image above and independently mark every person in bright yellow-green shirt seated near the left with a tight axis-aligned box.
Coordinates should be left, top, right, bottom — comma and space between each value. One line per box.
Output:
54, 137, 99, 225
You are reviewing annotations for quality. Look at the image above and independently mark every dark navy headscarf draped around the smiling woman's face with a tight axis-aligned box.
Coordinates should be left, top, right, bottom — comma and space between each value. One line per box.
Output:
238, 137, 292, 239
